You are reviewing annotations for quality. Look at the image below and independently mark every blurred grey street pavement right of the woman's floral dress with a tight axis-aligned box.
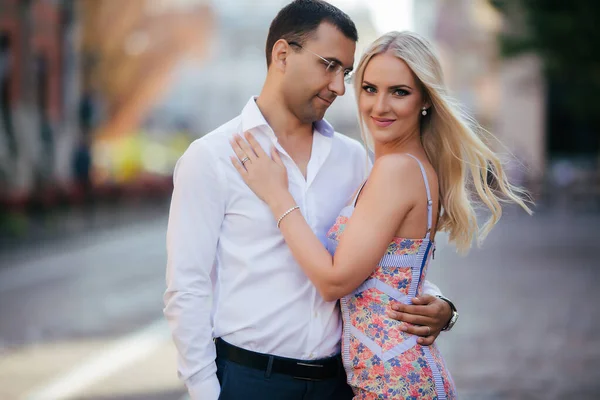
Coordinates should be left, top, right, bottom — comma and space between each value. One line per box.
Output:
429, 210, 600, 400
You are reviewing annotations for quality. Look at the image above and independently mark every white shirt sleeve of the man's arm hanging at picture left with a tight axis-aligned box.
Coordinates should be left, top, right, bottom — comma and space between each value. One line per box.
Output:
163, 139, 226, 400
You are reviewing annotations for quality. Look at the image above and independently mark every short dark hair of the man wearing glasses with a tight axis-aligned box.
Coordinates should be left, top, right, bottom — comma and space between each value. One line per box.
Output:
266, 0, 358, 67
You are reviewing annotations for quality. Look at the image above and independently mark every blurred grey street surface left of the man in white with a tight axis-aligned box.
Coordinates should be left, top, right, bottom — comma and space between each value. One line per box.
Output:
0, 210, 184, 400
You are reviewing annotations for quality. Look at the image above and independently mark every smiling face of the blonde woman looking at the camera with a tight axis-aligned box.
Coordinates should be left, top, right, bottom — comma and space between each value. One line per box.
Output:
358, 53, 428, 144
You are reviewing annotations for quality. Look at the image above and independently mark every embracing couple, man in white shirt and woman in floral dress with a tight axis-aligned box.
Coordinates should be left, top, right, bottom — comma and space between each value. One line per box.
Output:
164, 0, 529, 400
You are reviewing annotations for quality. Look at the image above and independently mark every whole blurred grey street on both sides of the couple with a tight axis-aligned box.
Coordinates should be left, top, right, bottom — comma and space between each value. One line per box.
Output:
0, 205, 600, 400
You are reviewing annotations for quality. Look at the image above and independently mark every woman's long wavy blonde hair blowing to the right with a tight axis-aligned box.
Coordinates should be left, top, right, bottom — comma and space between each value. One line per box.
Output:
354, 31, 531, 252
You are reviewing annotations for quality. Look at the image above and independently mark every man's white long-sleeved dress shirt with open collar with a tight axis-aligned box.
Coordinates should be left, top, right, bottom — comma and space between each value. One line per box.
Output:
164, 98, 441, 400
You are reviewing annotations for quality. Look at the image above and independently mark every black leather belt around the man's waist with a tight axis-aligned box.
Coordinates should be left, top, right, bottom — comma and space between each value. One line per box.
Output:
215, 338, 343, 381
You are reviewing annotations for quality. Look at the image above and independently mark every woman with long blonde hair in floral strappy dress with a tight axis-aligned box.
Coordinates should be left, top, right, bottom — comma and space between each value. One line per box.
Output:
232, 32, 530, 399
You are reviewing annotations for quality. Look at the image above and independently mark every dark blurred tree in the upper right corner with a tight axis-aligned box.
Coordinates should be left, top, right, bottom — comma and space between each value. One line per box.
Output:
490, 0, 600, 156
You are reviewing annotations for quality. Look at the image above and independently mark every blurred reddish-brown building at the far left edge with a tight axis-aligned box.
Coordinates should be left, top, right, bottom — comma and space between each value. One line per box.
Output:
0, 0, 78, 203
